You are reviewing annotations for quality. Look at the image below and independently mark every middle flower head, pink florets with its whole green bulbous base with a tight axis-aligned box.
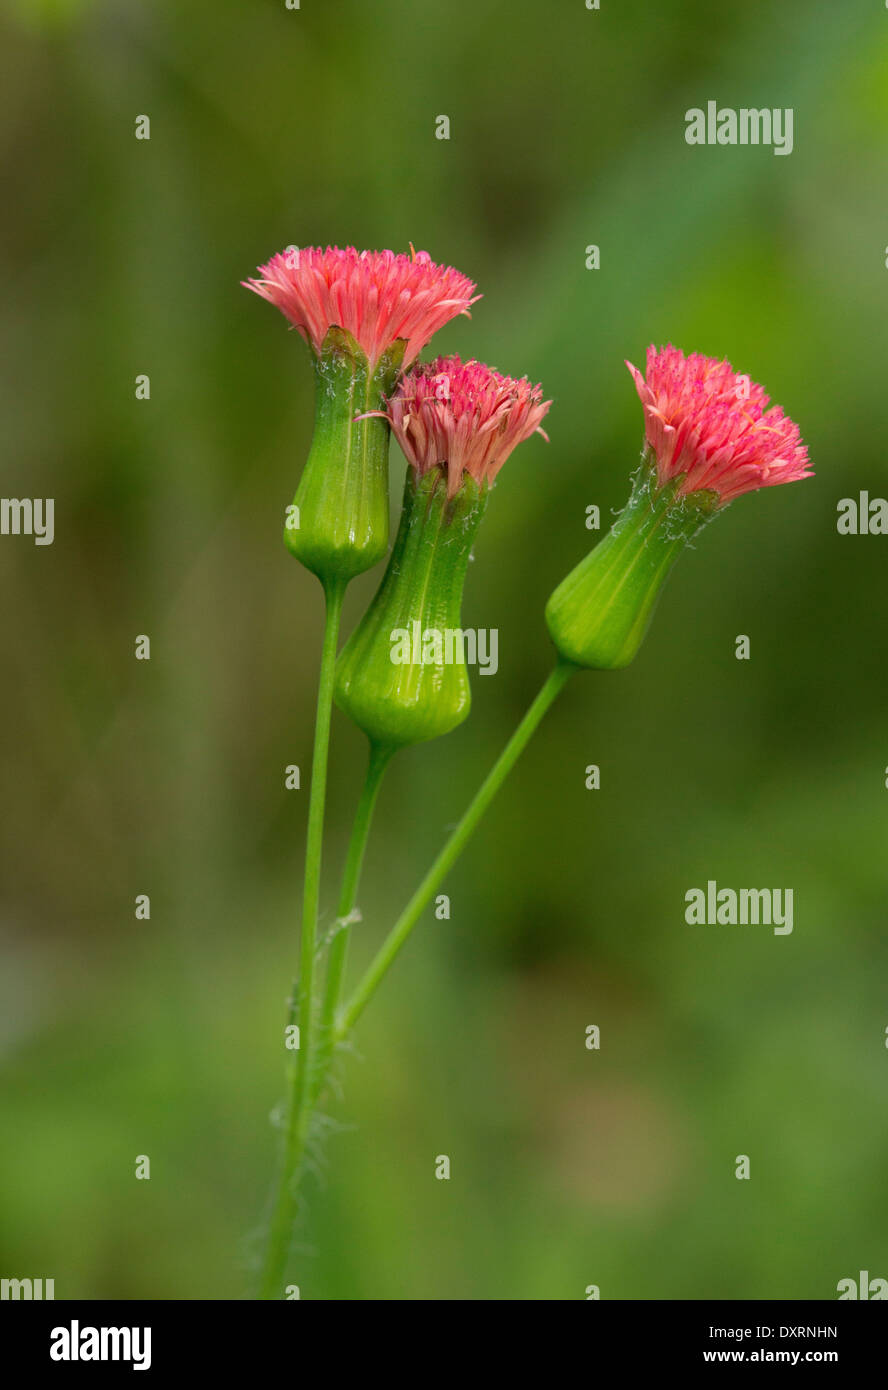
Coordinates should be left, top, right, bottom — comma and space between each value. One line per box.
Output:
336, 357, 549, 748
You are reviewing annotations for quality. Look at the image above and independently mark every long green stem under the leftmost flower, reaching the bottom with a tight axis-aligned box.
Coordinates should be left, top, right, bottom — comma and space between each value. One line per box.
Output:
260, 569, 346, 1298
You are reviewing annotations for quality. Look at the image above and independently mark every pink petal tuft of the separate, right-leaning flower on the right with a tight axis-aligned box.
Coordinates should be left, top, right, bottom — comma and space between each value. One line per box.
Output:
627, 346, 812, 506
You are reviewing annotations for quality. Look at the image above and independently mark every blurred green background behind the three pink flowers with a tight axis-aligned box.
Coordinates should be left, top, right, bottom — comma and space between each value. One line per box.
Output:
0, 0, 888, 1300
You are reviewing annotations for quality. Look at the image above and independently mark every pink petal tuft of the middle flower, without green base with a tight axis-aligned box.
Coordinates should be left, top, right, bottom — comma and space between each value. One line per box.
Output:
385, 357, 552, 498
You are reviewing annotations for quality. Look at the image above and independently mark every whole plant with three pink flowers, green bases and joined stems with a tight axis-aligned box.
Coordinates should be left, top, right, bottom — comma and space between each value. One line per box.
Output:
243, 246, 812, 1298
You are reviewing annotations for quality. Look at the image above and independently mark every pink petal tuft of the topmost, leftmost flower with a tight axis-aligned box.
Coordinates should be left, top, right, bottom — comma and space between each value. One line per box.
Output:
242, 246, 481, 371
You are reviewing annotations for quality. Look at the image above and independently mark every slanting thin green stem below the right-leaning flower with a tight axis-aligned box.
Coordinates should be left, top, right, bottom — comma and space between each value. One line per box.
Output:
335, 662, 578, 1041
